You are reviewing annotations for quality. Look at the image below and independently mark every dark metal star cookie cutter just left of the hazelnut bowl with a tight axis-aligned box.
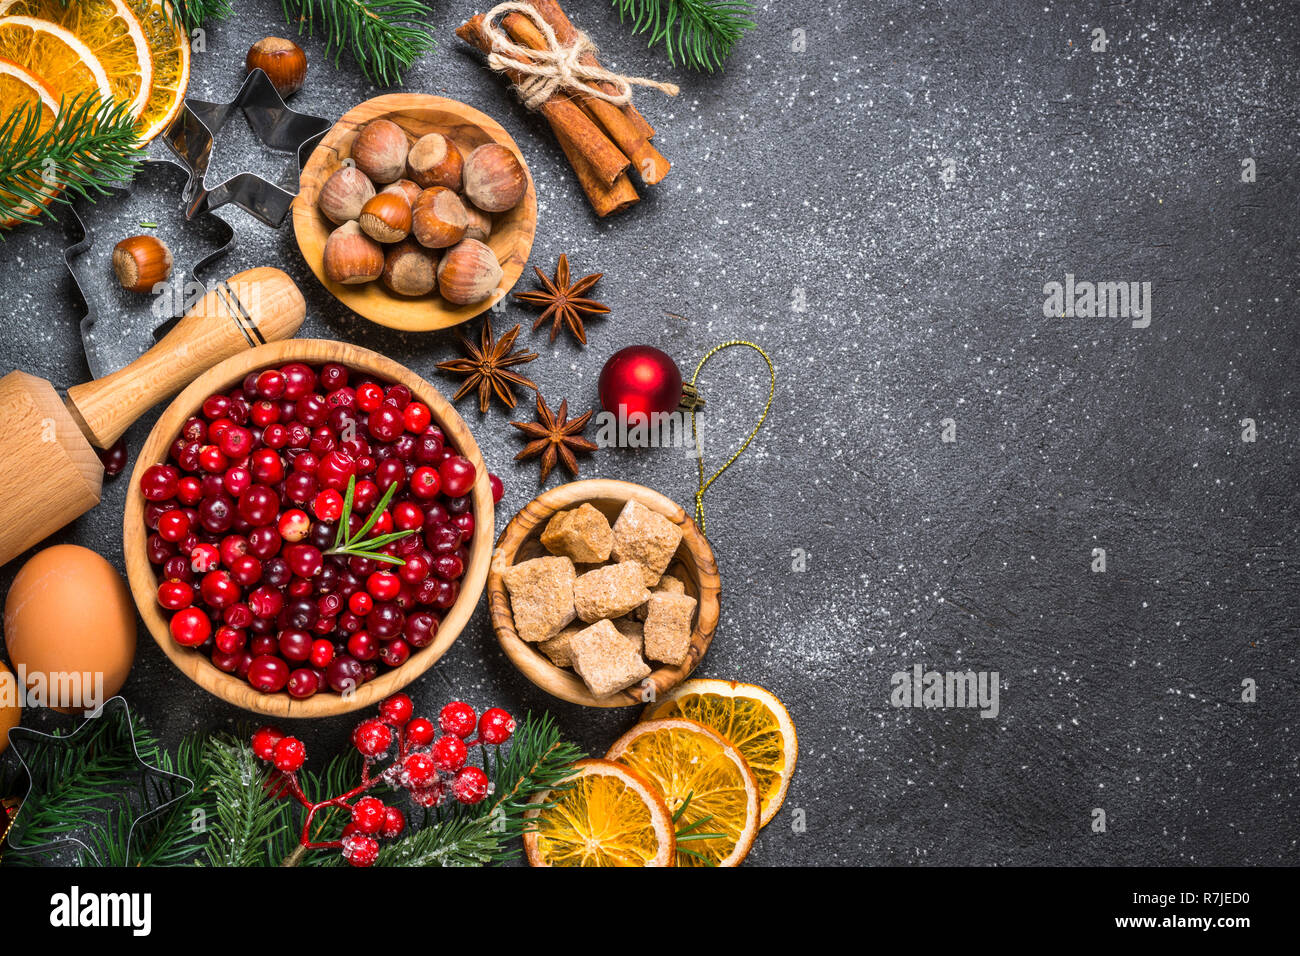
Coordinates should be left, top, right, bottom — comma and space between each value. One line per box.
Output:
163, 69, 333, 229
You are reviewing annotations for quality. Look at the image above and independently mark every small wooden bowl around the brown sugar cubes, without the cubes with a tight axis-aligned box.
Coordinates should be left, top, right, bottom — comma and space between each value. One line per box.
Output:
488, 479, 720, 708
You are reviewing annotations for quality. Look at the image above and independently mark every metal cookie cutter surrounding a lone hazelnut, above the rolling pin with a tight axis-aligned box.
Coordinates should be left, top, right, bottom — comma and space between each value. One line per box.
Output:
64, 159, 234, 378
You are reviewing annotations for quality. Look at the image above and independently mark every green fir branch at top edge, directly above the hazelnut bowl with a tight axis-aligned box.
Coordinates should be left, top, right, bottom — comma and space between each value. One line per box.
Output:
281, 0, 434, 86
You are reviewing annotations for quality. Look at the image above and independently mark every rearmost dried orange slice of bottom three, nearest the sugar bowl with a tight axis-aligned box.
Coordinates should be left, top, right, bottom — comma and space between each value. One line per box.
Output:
642, 679, 800, 827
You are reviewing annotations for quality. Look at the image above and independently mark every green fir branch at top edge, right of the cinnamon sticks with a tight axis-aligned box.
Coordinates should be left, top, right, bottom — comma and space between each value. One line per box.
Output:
614, 0, 754, 73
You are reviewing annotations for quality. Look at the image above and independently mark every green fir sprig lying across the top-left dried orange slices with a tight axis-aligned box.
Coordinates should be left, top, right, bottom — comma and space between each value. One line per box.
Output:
0, 92, 143, 231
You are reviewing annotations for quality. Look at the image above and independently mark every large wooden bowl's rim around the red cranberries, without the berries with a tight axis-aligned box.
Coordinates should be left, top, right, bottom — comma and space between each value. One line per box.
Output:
122, 338, 494, 718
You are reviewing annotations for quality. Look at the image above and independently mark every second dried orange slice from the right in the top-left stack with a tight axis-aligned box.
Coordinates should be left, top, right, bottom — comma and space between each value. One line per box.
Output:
0, 0, 153, 118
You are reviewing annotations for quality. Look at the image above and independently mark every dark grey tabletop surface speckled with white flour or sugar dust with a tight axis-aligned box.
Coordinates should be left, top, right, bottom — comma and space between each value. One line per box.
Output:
0, 0, 1300, 865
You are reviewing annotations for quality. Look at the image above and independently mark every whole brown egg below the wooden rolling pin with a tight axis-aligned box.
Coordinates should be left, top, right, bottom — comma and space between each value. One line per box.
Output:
4, 545, 135, 714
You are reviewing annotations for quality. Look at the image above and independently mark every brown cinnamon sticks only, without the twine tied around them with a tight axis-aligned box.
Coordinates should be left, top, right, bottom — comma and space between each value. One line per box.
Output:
456, 0, 671, 217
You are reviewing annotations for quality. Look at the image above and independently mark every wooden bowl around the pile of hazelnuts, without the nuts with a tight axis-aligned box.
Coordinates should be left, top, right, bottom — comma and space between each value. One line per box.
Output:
294, 92, 537, 332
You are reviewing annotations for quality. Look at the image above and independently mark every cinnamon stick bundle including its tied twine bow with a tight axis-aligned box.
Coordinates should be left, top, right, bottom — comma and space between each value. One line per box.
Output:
456, 0, 677, 216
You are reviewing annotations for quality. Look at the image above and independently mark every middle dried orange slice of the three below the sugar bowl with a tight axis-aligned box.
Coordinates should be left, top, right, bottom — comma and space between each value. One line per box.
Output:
605, 717, 759, 866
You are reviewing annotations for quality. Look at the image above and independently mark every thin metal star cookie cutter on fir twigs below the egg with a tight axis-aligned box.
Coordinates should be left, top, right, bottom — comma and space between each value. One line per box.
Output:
9, 696, 194, 866
